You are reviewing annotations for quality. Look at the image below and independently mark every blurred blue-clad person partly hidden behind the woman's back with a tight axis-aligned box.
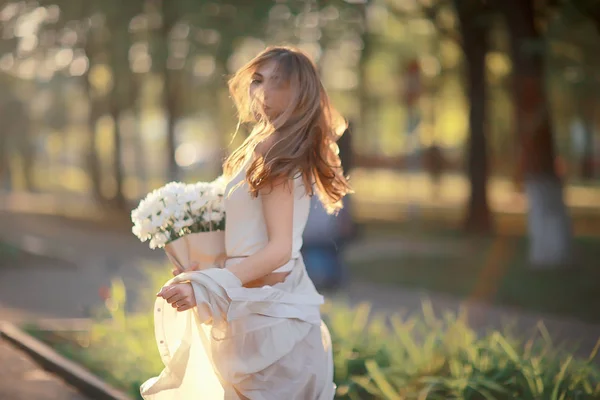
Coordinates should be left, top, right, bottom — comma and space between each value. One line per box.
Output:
302, 122, 356, 290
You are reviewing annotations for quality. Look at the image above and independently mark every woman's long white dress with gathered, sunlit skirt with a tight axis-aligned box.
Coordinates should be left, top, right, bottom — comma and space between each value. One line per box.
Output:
141, 171, 335, 400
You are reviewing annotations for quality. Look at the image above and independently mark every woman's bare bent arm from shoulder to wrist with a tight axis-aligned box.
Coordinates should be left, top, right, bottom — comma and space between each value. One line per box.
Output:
227, 179, 294, 285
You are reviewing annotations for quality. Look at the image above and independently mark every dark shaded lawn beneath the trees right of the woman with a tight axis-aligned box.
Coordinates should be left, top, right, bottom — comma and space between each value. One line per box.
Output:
348, 224, 600, 322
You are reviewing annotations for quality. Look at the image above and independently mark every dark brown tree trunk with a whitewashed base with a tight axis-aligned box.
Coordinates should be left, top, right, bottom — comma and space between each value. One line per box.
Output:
498, 0, 572, 268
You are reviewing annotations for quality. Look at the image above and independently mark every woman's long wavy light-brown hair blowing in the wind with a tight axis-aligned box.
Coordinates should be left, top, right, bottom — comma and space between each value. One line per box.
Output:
223, 47, 351, 213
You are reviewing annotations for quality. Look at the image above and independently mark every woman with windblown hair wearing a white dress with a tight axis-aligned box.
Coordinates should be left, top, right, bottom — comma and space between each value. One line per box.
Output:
142, 47, 350, 400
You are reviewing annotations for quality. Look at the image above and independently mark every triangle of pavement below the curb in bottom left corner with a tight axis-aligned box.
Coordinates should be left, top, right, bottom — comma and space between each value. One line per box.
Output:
0, 339, 89, 400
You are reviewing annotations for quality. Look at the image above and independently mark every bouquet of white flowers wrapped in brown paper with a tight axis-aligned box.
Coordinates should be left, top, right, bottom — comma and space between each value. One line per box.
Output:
131, 177, 225, 271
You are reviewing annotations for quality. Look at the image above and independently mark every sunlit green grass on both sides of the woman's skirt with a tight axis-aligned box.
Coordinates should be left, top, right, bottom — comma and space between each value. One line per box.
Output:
27, 268, 600, 400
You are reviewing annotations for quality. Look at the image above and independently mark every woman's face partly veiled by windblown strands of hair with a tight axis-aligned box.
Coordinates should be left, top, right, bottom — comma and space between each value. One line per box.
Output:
249, 61, 291, 120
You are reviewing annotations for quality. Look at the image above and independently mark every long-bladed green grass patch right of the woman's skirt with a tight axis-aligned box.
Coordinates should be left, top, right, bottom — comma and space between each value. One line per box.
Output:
324, 303, 600, 400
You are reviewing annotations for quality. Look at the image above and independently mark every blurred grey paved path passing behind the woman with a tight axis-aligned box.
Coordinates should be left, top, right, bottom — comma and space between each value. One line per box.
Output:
0, 213, 600, 360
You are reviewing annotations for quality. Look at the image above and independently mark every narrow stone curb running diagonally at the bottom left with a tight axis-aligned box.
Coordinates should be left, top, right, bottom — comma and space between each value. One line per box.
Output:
0, 321, 131, 400
